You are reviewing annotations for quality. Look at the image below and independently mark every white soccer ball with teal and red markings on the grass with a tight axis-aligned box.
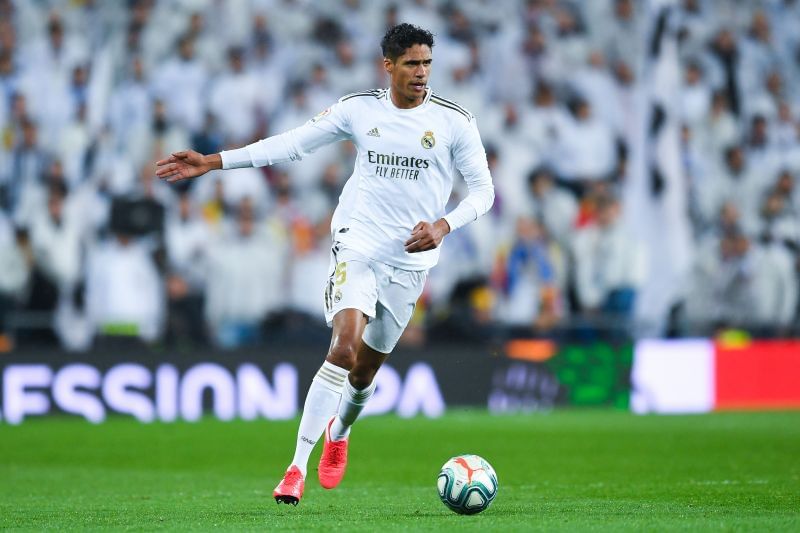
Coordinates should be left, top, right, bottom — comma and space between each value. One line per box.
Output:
436, 455, 497, 514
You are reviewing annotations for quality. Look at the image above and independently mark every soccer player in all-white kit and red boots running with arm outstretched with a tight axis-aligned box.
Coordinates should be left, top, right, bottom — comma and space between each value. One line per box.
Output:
156, 24, 494, 505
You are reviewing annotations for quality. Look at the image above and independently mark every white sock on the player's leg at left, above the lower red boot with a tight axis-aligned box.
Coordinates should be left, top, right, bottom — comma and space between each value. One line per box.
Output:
292, 361, 349, 477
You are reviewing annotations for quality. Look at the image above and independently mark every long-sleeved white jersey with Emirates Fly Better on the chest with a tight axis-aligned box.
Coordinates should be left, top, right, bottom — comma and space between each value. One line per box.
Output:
222, 89, 494, 270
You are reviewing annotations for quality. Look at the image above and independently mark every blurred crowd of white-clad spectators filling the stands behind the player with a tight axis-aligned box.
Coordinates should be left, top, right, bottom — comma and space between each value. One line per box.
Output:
0, 0, 800, 350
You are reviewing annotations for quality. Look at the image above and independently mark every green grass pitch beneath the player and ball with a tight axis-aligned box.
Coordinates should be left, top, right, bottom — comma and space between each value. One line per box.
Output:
0, 411, 800, 531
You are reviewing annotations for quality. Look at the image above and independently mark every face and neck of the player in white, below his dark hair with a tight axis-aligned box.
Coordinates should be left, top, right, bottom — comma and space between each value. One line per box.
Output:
383, 44, 433, 109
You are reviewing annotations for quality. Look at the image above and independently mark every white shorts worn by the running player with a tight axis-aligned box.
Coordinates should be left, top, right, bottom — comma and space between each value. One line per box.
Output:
325, 241, 428, 354
